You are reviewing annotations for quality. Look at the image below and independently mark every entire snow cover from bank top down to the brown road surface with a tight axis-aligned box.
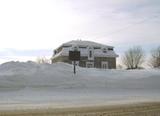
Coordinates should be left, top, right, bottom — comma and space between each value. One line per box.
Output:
0, 62, 160, 109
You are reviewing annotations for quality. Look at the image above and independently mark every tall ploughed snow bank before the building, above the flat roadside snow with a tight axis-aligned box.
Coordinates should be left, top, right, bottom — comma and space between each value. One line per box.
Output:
0, 62, 160, 89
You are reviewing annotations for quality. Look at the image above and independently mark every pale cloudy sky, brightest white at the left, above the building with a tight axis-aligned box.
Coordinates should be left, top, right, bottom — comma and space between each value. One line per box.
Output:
0, 0, 160, 63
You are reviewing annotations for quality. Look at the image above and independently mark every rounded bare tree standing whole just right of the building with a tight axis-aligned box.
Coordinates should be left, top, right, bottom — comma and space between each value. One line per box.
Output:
122, 46, 145, 69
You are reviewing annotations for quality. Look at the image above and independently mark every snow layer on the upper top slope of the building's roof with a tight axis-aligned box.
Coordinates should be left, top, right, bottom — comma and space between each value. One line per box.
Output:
58, 40, 113, 48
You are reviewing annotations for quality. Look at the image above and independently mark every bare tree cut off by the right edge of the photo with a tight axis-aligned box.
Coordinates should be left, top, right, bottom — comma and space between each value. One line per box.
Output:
150, 46, 160, 68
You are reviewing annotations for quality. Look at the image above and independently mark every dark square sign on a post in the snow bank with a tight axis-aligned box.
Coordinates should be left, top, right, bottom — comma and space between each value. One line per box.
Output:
69, 51, 80, 74
